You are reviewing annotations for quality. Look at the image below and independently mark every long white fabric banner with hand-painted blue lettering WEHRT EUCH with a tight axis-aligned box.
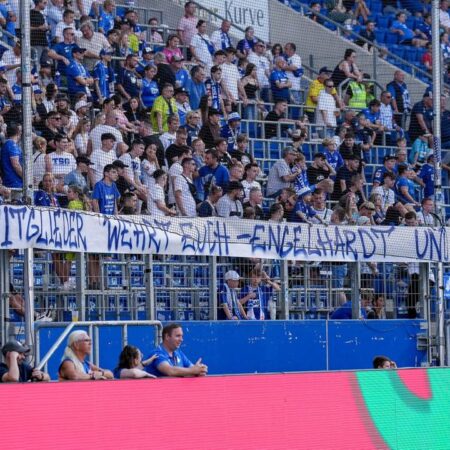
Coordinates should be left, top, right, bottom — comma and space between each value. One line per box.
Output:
0, 205, 450, 262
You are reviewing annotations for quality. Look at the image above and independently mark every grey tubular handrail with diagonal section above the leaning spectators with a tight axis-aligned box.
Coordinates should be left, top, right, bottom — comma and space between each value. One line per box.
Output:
34, 320, 162, 370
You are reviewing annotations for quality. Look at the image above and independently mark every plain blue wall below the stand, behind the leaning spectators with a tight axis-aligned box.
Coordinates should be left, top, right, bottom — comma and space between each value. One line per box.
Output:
38, 320, 426, 379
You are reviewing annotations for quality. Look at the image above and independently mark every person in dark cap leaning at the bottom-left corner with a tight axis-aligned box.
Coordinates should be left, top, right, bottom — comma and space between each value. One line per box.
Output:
0, 341, 50, 383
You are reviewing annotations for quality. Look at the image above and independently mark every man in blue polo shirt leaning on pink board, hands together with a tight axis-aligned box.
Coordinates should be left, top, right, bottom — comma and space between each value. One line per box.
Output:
145, 323, 208, 377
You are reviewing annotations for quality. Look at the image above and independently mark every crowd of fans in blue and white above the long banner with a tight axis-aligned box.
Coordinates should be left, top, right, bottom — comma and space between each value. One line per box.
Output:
0, 0, 442, 318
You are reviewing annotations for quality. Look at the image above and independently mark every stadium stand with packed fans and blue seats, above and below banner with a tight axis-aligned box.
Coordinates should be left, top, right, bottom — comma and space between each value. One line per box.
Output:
0, 0, 450, 358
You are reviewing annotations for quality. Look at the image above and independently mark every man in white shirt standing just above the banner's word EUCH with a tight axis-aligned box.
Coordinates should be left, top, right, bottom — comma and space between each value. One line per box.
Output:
174, 158, 197, 217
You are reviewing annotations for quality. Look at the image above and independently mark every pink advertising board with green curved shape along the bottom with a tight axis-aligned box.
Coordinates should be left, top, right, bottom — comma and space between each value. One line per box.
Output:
0, 368, 450, 450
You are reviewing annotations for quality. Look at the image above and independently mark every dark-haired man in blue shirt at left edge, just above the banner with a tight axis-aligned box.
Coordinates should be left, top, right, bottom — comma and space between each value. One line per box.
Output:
1, 124, 23, 188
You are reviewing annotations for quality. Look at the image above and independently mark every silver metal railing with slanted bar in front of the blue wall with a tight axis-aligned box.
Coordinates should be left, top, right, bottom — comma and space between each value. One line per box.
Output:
34, 320, 162, 371
